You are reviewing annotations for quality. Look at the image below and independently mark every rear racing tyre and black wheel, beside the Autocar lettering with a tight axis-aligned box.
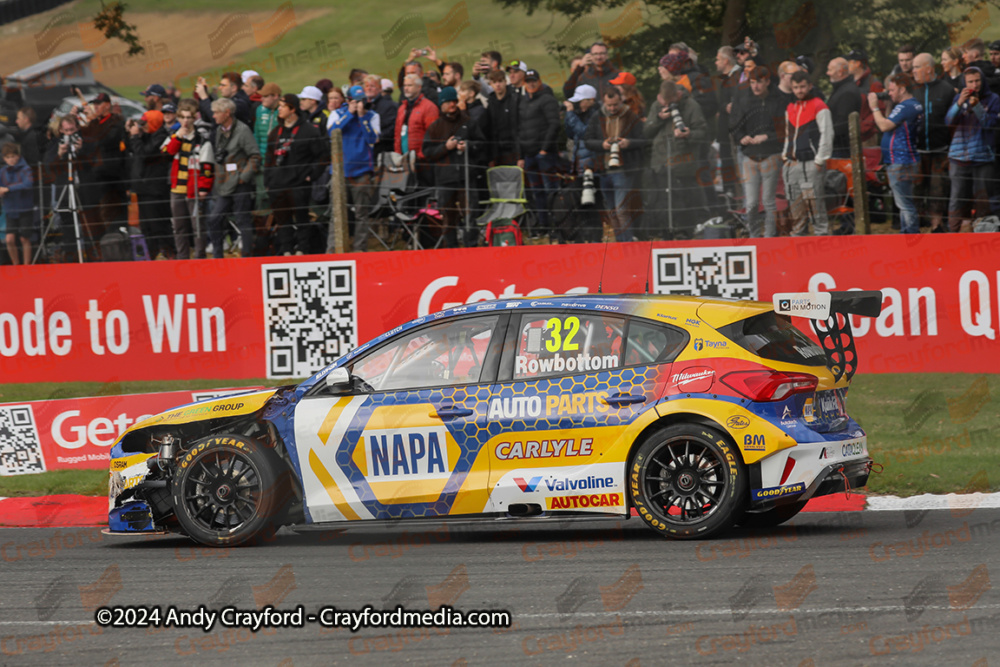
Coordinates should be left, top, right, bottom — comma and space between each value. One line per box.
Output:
629, 424, 747, 540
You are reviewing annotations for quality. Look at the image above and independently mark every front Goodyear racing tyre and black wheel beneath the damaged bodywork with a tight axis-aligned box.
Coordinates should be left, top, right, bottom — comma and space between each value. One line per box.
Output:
171, 435, 286, 547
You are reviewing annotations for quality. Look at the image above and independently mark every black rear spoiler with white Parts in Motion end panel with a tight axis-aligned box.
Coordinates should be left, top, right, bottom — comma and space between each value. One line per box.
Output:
774, 290, 882, 382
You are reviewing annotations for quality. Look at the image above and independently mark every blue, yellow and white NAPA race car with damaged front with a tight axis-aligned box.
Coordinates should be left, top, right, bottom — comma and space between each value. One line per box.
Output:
108, 291, 882, 546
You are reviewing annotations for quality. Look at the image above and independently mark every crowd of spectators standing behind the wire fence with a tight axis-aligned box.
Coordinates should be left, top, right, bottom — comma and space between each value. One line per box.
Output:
0, 38, 1000, 264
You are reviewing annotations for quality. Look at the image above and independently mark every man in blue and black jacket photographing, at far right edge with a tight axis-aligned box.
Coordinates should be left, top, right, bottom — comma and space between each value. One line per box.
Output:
945, 67, 1000, 232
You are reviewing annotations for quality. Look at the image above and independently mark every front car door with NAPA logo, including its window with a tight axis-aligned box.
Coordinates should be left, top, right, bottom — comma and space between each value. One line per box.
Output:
295, 314, 507, 522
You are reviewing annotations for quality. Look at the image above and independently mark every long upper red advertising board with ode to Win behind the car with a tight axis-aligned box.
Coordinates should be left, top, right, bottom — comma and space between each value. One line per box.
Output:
0, 234, 1000, 383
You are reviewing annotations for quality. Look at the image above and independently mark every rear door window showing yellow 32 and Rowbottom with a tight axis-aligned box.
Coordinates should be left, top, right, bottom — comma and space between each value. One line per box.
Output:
513, 311, 625, 380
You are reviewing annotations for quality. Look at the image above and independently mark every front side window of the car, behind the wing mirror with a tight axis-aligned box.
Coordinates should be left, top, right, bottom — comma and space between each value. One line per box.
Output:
349, 315, 500, 391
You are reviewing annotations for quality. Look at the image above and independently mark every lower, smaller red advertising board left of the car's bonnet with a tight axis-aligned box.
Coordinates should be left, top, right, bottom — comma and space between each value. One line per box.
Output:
0, 387, 262, 475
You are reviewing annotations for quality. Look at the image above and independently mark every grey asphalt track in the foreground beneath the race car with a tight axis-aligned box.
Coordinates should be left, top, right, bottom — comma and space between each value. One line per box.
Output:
0, 508, 1000, 667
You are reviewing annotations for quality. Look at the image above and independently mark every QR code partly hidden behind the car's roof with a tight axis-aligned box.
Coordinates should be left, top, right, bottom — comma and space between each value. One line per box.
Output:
653, 245, 757, 300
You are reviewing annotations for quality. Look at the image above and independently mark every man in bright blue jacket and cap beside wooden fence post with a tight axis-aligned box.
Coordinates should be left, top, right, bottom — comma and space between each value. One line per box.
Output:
326, 86, 378, 252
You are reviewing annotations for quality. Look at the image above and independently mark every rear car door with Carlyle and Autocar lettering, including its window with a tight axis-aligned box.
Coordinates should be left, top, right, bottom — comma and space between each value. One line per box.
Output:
488, 310, 687, 512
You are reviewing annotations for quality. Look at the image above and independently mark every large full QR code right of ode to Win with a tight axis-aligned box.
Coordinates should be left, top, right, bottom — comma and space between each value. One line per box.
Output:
261, 261, 358, 378
